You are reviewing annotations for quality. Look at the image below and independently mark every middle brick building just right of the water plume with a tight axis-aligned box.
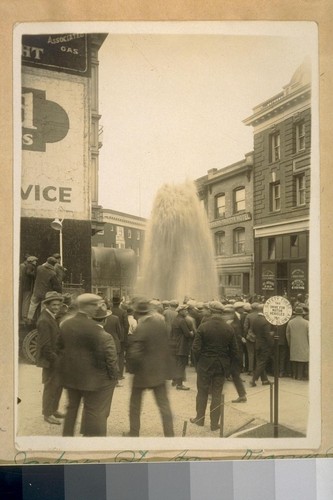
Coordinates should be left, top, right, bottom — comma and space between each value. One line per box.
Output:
196, 153, 254, 297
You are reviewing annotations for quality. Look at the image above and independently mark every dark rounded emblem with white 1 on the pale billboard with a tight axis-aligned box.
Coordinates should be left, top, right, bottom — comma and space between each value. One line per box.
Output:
21, 87, 69, 151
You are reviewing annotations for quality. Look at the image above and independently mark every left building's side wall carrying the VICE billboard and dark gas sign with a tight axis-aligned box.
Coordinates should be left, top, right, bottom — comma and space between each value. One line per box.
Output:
20, 33, 106, 291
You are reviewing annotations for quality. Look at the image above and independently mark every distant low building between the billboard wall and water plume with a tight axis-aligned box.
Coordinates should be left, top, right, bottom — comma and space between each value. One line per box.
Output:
92, 208, 147, 299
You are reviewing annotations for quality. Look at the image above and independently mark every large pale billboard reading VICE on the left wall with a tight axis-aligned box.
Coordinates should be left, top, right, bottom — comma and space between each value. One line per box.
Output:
21, 70, 90, 220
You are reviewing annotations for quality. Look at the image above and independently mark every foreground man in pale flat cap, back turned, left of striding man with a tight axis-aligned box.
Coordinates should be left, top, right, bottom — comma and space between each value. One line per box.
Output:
59, 293, 118, 436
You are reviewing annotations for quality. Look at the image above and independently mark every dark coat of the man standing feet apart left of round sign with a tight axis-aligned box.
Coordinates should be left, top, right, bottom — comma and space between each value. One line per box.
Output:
192, 314, 238, 373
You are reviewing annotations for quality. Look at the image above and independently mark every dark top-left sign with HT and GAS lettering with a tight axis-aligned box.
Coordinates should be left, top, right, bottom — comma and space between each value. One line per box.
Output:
22, 33, 90, 76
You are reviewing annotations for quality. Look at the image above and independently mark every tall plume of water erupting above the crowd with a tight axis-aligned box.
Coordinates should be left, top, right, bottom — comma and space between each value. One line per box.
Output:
139, 181, 217, 301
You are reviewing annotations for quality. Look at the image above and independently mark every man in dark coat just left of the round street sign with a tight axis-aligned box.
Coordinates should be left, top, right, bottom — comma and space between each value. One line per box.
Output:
250, 304, 274, 387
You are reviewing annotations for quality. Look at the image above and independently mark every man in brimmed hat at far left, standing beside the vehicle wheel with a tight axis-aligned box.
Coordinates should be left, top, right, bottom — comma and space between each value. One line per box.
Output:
36, 292, 64, 425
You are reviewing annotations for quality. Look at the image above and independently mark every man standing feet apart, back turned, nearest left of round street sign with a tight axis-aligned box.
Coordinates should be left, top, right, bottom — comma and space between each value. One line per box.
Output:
190, 301, 238, 431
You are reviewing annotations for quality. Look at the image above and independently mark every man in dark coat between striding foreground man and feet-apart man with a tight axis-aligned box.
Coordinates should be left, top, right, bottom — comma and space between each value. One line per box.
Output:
170, 304, 193, 391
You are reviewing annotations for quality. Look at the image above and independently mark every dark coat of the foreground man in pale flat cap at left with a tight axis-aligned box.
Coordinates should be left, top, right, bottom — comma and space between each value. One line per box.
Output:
59, 312, 118, 391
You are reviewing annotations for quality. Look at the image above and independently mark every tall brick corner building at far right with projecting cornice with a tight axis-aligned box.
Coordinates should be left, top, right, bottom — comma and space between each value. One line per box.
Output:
244, 60, 311, 297
